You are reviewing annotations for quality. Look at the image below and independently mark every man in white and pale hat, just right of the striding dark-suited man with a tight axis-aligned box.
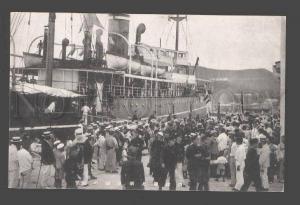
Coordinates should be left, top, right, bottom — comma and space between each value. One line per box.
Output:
259, 135, 271, 191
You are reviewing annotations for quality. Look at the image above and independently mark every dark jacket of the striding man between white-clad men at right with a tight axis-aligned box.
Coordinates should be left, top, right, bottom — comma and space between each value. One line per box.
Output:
244, 147, 260, 176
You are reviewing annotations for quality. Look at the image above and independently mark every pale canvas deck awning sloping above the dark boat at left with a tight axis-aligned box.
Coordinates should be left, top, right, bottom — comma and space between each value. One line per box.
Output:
9, 82, 84, 98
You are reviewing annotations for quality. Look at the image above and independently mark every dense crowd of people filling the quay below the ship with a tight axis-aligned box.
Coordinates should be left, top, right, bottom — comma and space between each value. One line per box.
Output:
9, 110, 285, 191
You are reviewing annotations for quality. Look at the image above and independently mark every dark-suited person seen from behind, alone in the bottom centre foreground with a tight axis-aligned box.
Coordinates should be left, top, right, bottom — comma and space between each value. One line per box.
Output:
121, 146, 145, 190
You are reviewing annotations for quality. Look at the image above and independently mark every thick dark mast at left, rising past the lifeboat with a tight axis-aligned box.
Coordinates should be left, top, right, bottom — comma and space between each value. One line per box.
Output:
46, 12, 56, 87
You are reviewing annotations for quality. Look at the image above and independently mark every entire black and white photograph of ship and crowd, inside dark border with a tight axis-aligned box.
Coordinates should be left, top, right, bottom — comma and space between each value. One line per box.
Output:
5, 11, 287, 192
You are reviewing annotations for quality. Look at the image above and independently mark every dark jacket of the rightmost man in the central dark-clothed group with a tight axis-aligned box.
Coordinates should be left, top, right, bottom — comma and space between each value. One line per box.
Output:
186, 144, 209, 169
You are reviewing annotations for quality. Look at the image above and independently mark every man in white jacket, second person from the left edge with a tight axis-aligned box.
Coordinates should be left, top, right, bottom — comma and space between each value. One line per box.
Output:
17, 139, 33, 189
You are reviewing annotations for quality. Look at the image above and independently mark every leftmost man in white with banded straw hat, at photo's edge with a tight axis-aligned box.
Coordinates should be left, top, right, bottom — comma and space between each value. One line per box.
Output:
8, 137, 22, 188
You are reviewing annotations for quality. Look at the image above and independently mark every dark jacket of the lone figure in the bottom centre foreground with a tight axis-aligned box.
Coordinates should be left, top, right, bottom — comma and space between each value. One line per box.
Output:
121, 159, 145, 189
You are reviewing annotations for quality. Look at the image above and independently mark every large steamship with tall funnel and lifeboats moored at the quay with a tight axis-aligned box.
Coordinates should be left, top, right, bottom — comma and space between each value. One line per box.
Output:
9, 13, 211, 126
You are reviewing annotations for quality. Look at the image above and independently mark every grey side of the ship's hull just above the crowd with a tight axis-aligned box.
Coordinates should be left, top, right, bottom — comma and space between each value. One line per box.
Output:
111, 97, 206, 119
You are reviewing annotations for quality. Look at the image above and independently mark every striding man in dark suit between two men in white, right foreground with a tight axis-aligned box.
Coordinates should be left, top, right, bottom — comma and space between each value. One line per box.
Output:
241, 138, 262, 191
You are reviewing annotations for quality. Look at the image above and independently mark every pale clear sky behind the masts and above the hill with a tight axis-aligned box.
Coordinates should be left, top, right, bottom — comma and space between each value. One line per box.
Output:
11, 13, 281, 71
